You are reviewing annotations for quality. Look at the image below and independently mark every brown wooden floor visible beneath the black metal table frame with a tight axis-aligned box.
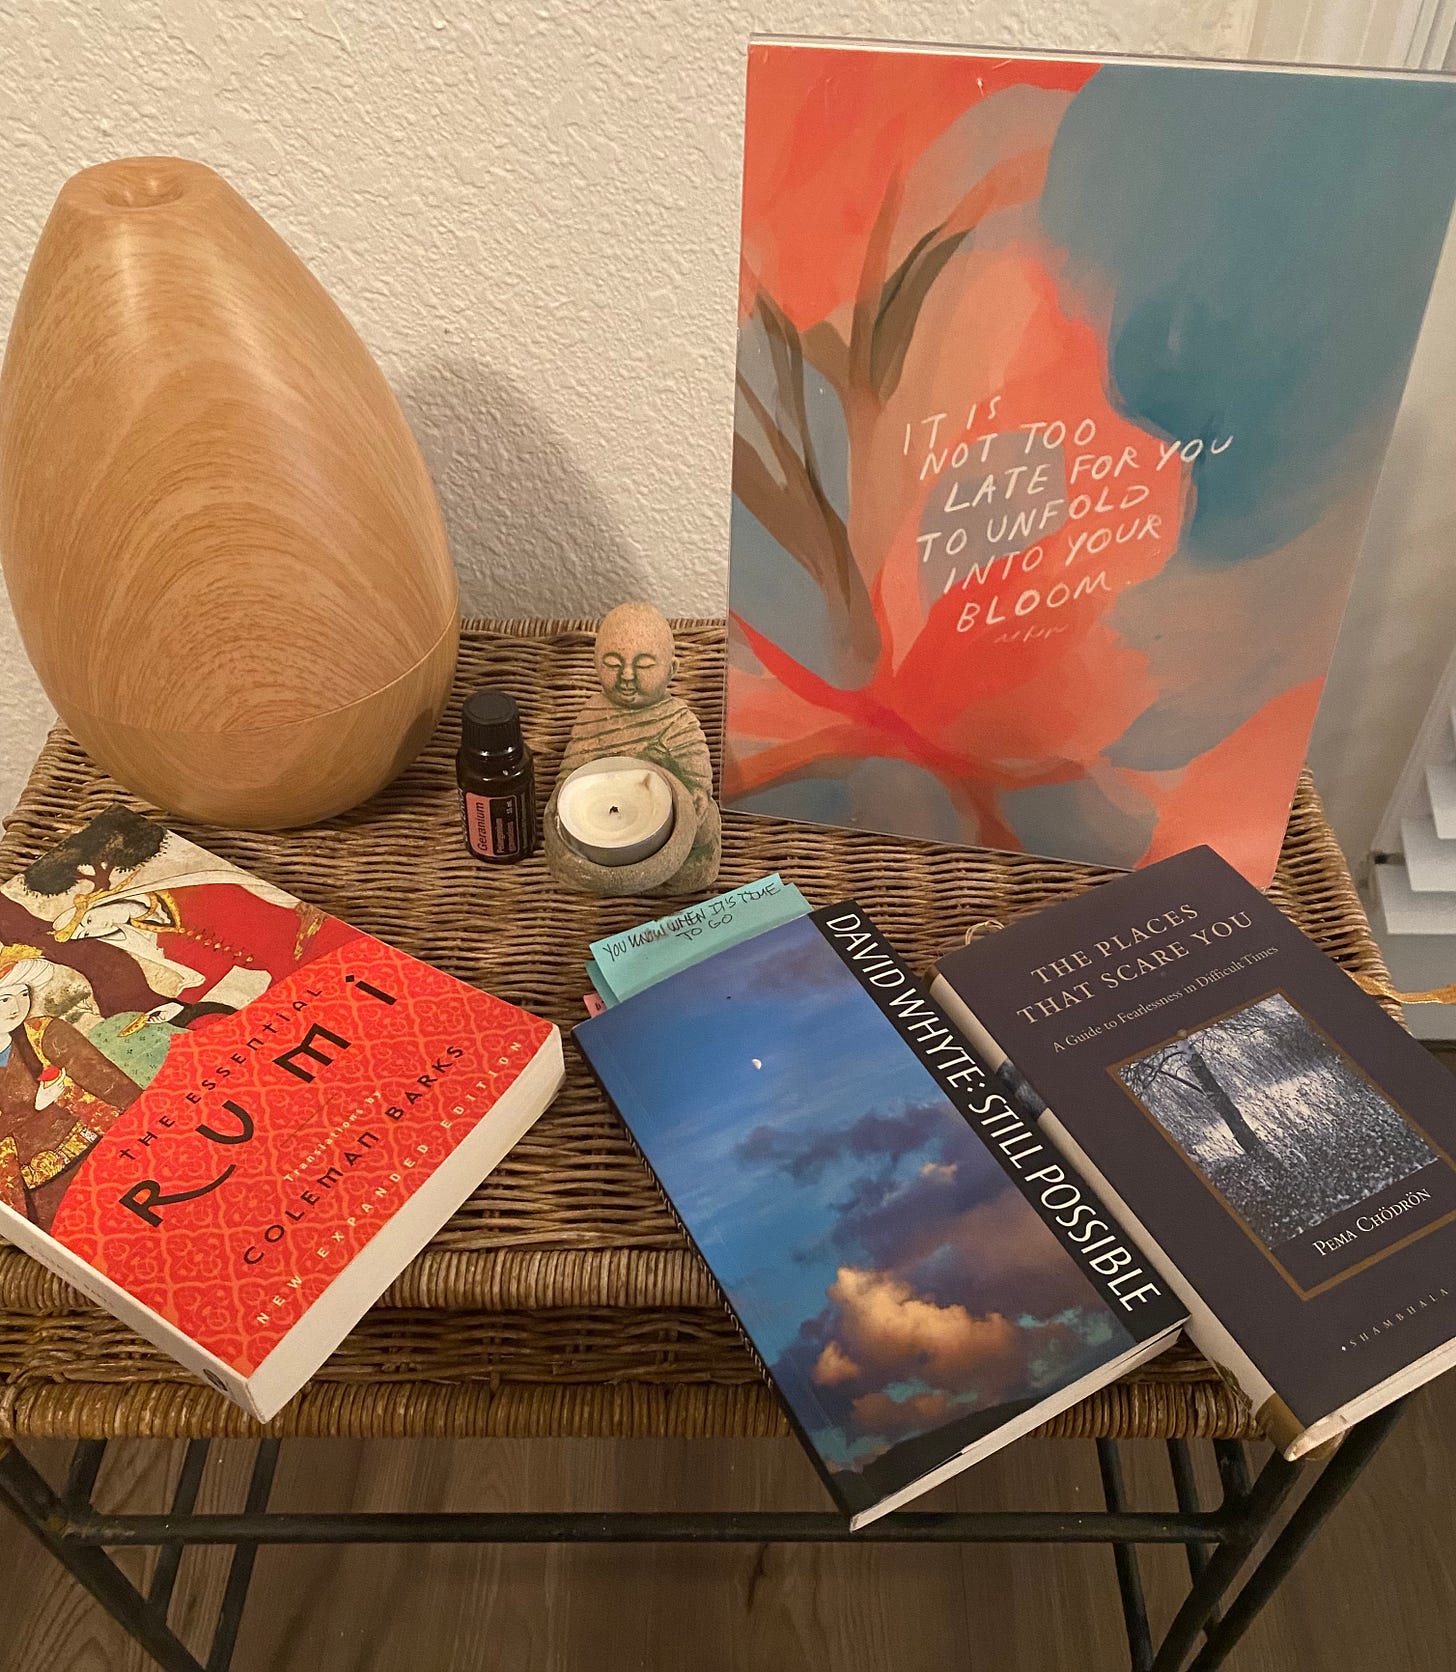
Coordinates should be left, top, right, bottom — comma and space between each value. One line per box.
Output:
0, 1036, 1456, 1672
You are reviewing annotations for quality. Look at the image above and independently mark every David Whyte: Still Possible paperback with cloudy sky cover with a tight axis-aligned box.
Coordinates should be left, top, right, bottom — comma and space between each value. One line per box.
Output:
573, 901, 1184, 1528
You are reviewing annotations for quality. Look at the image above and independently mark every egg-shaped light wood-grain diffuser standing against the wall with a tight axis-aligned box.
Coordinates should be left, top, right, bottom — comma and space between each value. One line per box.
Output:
0, 157, 458, 829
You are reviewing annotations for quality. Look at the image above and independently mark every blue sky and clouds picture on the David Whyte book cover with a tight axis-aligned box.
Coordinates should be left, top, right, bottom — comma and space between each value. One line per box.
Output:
578, 918, 1132, 1485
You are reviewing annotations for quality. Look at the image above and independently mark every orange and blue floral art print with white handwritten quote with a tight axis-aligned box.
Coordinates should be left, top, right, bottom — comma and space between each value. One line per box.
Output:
724, 43, 1456, 886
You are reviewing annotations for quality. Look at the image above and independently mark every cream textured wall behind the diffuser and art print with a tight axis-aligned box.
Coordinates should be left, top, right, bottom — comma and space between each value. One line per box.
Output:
17, 0, 1397, 836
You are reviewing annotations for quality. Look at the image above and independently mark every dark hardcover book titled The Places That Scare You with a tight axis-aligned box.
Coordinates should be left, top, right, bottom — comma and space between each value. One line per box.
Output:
931, 848, 1456, 1458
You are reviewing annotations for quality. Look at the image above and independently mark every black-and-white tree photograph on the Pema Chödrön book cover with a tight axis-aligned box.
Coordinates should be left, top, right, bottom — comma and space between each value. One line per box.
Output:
1113, 993, 1436, 1249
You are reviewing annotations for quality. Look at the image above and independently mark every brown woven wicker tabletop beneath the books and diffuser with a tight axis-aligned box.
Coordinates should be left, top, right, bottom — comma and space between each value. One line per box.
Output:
0, 622, 1387, 1438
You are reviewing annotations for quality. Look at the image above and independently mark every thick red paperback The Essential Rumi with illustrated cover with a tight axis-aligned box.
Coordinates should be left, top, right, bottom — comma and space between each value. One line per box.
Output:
0, 808, 563, 1421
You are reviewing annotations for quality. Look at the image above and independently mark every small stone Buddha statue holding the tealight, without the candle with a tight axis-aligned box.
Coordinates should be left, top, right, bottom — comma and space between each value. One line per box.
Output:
545, 604, 722, 895
